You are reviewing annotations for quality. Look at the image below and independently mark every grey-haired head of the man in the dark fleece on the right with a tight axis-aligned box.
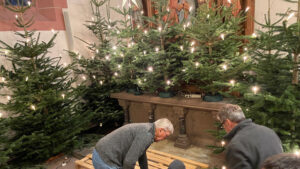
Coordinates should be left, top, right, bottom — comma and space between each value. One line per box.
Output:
217, 104, 245, 133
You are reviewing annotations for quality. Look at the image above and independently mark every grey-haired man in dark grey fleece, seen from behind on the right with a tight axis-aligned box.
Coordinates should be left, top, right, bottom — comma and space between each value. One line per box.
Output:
218, 104, 282, 169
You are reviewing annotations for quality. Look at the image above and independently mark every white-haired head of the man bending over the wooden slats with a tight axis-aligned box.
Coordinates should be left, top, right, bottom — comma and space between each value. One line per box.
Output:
154, 118, 174, 141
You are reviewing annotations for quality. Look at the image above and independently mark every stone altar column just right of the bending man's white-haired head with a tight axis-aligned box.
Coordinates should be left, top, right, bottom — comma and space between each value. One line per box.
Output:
173, 107, 190, 148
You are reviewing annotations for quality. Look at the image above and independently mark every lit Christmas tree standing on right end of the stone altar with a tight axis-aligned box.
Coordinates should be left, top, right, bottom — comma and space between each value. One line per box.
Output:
182, 3, 247, 97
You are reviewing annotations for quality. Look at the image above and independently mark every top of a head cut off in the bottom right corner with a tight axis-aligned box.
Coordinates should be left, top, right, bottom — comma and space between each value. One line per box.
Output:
262, 153, 300, 169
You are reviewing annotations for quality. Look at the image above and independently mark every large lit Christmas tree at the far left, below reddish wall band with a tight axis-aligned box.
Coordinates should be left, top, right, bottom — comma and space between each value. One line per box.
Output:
0, 1, 89, 168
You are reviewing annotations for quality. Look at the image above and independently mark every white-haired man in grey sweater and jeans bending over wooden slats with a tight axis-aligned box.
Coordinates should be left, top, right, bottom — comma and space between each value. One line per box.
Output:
92, 118, 174, 169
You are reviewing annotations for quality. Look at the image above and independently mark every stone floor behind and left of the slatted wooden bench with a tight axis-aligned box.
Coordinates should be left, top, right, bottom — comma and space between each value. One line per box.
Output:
46, 140, 223, 169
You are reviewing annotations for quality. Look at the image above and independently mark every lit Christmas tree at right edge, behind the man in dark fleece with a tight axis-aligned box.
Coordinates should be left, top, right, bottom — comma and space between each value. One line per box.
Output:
234, 1, 300, 151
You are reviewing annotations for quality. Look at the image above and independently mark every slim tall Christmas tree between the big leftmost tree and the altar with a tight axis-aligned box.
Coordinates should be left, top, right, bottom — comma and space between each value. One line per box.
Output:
70, 0, 123, 126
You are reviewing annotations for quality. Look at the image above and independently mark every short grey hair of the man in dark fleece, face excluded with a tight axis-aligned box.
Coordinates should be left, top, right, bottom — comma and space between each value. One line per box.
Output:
218, 104, 245, 123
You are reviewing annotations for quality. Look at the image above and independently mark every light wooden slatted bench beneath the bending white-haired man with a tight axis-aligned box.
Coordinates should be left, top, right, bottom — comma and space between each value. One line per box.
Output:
75, 149, 208, 169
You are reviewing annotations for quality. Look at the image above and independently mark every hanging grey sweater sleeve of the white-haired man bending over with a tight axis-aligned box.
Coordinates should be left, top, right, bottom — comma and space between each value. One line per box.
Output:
123, 135, 151, 169
